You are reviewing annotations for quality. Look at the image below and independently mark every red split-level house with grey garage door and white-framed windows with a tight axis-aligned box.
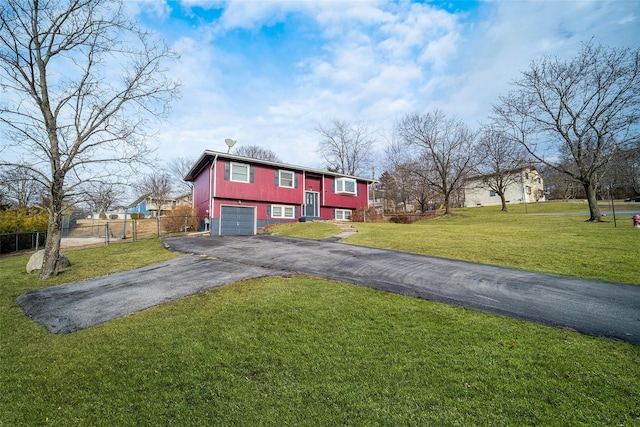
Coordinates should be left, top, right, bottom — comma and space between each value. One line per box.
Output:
184, 150, 376, 235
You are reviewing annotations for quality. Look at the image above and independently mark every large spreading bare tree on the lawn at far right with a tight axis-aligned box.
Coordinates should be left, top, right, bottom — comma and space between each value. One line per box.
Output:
494, 42, 640, 222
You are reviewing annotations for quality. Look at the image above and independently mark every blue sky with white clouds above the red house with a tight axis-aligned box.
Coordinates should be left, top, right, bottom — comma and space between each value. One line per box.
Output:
127, 0, 640, 171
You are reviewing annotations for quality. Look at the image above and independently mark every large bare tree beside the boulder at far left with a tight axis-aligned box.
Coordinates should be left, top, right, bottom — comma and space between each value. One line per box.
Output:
0, 0, 178, 279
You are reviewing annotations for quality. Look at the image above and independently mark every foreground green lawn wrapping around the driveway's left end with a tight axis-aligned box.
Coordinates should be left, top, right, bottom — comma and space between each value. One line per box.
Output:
0, 210, 640, 426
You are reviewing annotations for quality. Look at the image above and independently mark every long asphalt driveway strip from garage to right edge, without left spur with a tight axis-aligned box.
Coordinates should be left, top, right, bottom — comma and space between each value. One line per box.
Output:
164, 236, 640, 345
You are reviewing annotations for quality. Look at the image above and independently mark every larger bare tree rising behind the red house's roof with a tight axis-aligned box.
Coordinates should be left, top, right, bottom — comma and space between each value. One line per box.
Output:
316, 119, 376, 175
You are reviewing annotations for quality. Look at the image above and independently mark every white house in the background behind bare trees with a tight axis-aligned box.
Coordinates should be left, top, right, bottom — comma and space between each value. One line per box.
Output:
464, 167, 546, 207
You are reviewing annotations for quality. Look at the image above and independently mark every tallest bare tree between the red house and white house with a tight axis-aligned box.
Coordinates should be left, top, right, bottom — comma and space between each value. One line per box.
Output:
397, 110, 475, 215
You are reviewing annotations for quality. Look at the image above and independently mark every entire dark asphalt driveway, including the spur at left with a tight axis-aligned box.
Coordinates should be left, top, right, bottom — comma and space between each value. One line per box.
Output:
18, 236, 640, 345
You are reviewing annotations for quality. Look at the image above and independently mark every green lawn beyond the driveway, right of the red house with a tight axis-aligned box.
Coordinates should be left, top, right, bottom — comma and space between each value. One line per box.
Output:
330, 202, 640, 284
